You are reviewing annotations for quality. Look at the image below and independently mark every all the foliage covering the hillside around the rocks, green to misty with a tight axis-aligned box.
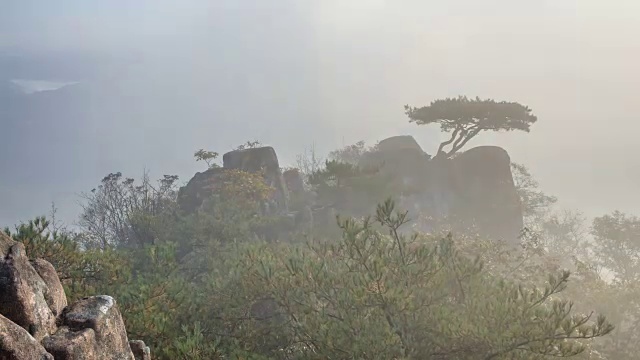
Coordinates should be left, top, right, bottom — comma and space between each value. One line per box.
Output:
7, 143, 640, 360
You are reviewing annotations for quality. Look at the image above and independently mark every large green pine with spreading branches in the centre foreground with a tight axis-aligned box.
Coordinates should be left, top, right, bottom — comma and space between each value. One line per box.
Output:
202, 202, 612, 359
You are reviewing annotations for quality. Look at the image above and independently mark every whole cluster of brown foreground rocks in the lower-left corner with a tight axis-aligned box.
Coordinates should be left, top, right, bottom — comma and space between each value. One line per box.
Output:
0, 233, 150, 360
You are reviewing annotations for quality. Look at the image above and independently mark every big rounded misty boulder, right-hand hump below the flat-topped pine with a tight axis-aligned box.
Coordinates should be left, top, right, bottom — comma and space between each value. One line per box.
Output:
408, 146, 523, 243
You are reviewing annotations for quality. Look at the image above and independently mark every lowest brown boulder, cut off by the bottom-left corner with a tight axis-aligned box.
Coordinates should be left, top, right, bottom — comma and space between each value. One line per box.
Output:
0, 315, 54, 360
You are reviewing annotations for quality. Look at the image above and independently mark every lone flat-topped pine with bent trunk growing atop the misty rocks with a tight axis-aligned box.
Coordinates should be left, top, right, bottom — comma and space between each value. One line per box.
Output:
404, 96, 537, 158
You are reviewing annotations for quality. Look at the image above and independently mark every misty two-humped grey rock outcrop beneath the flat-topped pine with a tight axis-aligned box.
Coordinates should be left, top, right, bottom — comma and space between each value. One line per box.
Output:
360, 136, 523, 242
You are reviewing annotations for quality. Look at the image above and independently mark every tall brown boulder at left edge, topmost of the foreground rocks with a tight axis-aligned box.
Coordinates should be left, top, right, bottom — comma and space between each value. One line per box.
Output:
0, 243, 56, 341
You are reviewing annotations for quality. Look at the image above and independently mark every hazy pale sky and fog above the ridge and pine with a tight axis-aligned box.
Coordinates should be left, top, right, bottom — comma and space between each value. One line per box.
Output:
0, 0, 640, 228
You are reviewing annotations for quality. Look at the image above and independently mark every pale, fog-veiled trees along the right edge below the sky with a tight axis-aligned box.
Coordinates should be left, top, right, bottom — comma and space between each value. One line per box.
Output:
490, 163, 640, 360
